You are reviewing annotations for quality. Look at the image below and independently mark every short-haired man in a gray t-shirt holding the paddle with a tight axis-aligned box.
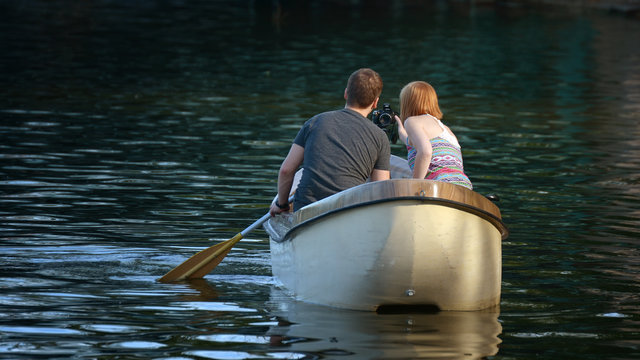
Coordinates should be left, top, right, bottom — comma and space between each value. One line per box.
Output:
270, 68, 391, 216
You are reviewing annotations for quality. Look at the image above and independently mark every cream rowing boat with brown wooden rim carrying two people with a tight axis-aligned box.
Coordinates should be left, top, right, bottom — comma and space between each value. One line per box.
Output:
265, 159, 508, 311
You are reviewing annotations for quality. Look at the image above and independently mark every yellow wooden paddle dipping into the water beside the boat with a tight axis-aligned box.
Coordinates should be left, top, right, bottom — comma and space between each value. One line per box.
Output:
158, 196, 293, 282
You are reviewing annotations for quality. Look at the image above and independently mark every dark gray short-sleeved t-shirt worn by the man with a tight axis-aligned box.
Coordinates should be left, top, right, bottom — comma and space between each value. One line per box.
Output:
293, 109, 391, 210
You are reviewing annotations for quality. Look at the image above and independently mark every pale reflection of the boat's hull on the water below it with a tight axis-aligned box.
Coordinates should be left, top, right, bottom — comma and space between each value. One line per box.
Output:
268, 288, 502, 359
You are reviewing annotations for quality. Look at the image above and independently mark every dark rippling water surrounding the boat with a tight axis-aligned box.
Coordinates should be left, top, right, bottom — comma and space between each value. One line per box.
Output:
0, 0, 640, 359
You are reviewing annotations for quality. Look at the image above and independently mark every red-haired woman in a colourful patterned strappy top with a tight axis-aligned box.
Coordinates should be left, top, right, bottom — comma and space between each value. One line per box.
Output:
396, 81, 473, 189
